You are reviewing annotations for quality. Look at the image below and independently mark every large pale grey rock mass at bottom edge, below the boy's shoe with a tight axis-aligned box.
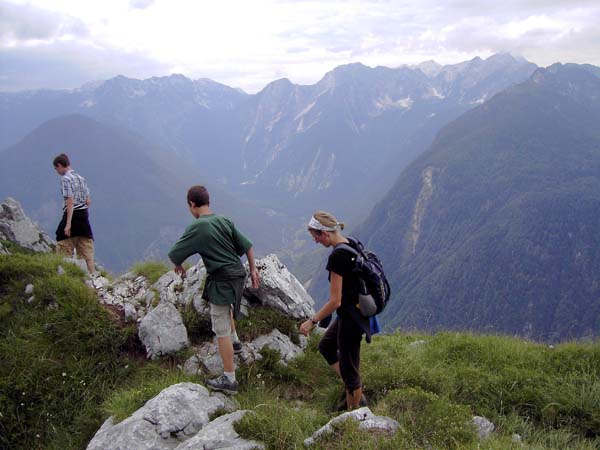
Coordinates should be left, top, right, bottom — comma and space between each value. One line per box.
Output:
87, 383, 260, 450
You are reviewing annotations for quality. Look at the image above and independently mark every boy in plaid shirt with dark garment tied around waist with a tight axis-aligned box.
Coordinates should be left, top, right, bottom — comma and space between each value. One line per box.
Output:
52, 153, 96, 273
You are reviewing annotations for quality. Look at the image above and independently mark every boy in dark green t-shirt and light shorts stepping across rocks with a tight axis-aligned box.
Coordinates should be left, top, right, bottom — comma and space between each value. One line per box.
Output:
169, 186, 260, 394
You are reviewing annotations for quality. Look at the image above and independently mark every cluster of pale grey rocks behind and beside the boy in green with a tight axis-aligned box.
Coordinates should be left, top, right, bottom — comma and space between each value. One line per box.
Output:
88, 255, 314, 362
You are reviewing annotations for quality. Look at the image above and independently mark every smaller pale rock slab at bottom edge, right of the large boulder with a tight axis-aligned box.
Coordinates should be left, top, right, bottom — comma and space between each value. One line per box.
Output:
175, 410, 264, 450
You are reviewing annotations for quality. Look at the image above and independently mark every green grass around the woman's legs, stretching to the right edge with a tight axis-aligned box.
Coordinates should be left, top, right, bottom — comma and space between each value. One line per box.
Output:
236, 333, 600, 450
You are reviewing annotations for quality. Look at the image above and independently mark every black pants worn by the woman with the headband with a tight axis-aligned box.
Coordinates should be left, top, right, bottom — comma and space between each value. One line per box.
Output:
319, 317, 363, 392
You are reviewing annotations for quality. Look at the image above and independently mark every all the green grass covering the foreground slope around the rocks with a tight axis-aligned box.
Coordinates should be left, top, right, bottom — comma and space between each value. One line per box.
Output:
0, 254, 600, 449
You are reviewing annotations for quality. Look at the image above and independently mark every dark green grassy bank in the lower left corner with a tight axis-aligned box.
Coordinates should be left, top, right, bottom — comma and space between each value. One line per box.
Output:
0, 254, 131, 448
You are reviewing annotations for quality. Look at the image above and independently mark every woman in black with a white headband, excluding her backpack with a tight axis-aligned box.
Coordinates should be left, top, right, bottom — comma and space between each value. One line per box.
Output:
300, 211, 371, 410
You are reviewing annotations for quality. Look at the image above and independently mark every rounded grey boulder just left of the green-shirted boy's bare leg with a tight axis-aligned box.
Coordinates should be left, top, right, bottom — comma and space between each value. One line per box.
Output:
138, 302, 189, 359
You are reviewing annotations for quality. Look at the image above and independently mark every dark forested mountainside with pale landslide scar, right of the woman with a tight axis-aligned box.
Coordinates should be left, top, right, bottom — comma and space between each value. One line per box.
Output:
355, 64, 600, 341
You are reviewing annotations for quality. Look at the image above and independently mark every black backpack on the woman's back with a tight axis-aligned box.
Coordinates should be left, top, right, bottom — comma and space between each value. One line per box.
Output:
335, 238, 390, 317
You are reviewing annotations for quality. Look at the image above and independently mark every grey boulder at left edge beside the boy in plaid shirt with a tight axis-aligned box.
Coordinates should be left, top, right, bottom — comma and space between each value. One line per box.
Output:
0, 197, 55, 252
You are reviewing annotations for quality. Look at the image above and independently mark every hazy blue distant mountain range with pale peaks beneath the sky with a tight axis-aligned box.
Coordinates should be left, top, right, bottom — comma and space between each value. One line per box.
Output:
0, 55, 536, 214
